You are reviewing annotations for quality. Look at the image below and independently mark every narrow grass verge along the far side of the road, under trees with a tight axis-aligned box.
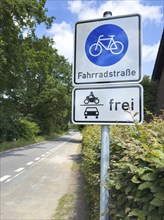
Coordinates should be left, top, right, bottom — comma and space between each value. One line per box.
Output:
0, 133, 63, 152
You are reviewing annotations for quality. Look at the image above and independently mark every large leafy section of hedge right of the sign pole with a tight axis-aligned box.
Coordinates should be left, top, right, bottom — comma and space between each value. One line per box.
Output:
109, 118, 164, 220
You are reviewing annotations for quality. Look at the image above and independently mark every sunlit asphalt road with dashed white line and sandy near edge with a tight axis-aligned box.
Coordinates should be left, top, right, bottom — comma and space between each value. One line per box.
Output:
0, 133, 80, 220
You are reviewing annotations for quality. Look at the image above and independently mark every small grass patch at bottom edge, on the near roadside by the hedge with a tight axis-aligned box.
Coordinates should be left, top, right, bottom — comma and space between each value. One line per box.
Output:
52, 194, 75, 220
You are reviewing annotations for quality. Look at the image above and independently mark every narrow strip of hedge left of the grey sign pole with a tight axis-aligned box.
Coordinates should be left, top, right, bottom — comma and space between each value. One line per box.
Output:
82, 126, 101, 220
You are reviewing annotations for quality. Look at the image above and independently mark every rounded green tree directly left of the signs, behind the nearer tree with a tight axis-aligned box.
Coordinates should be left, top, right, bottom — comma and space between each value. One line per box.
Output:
19, 36, 71, 133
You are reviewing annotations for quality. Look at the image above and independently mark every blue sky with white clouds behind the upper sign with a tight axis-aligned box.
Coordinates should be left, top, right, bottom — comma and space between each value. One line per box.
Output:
37, 0, 164, 77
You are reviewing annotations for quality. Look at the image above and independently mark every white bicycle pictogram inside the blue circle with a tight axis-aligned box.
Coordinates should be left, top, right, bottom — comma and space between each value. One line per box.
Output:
89, 35, 124, 57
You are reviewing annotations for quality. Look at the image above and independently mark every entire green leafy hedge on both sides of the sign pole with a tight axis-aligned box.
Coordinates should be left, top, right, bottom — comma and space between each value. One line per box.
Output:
82, 118, 164, 220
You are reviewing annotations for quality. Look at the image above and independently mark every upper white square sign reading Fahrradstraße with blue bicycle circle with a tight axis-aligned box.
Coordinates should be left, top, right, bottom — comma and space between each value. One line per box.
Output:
73, 14, 142, 86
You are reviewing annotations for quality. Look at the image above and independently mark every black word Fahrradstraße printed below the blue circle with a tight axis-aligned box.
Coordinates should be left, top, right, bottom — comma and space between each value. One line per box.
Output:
78, 69, 136, 79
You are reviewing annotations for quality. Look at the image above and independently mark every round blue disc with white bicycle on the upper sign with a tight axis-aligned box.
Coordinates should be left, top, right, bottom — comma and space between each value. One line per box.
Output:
85, 24, 128, 66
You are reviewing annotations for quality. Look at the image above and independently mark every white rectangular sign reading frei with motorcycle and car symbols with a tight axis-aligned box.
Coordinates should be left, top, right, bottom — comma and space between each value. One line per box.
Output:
72, 85, 143, 125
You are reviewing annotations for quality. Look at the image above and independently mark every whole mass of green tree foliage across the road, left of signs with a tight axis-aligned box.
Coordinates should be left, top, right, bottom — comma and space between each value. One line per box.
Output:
0, 0, 71, 141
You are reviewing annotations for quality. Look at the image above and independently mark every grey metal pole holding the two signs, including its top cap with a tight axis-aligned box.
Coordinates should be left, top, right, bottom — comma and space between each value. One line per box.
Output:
100, 11, 112, 220
